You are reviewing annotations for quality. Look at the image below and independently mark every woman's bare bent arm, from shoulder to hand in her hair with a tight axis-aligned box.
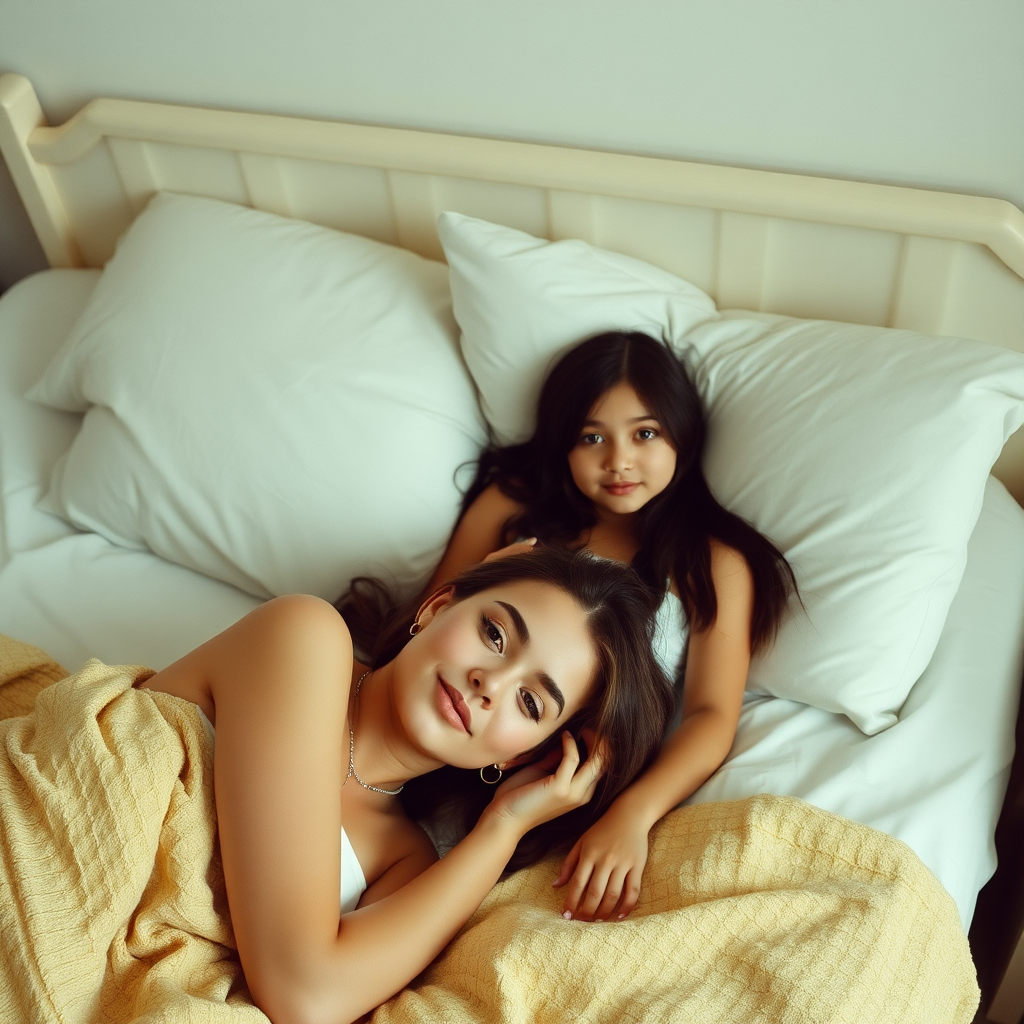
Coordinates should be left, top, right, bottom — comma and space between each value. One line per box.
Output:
147, 596, 599, 1024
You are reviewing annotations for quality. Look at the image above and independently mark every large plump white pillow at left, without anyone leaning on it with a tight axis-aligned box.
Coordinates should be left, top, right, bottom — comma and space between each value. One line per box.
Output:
30, 194, 485, 598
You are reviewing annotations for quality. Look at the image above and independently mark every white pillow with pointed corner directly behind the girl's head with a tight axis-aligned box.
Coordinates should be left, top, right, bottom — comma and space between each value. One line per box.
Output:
437, 213, 718, 444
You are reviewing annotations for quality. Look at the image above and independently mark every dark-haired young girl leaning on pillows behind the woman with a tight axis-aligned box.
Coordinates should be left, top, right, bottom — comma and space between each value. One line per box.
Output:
431, 332, 797, 921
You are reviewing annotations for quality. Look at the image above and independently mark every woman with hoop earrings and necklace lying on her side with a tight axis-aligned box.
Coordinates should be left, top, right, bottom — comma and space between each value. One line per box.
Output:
144, 549, 672, 1024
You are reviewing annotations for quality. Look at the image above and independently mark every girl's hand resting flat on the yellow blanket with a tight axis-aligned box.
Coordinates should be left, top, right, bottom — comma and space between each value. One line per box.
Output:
554, 804, 648, 921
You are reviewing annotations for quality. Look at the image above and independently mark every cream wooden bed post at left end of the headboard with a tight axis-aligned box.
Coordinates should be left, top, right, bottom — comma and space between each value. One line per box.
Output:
0, 75, 83, 266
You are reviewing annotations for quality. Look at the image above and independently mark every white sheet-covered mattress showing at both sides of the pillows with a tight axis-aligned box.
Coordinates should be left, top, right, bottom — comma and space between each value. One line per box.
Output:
0, 270, 1024, 929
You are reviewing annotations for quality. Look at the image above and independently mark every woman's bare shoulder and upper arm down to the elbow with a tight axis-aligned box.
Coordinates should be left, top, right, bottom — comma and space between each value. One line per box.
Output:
147, 596, 352, 1024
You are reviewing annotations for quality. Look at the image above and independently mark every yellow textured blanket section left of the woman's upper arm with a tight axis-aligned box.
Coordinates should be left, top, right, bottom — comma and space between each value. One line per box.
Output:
0, 637, 266, 1024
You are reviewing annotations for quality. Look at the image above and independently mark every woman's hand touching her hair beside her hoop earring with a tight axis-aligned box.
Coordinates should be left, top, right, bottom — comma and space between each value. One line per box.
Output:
487, 731, 601, 835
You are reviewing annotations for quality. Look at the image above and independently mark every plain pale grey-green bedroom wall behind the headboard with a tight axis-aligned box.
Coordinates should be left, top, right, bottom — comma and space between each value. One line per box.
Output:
0, 0, 1024, 285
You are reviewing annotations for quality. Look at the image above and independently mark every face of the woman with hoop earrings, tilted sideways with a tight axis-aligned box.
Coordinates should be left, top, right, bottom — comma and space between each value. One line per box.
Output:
394, 581, 597, 768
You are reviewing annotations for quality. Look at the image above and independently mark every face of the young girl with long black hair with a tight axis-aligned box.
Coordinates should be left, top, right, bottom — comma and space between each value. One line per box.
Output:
568, 382, 676, 515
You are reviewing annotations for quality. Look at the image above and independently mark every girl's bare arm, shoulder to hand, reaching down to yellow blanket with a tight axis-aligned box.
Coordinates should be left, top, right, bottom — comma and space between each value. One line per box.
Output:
554, 542, 754, 921
